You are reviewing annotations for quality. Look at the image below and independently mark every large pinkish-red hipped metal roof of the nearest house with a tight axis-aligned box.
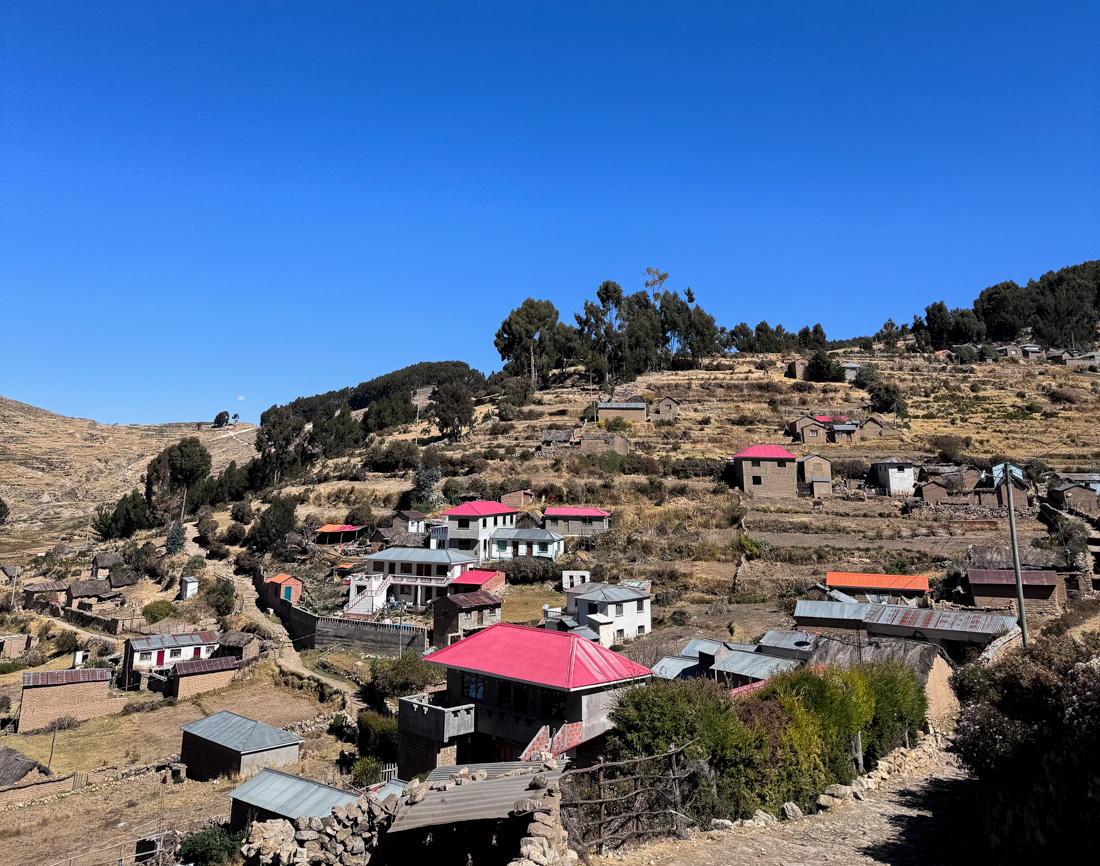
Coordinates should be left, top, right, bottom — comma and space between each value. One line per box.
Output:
425, 623, 651, 691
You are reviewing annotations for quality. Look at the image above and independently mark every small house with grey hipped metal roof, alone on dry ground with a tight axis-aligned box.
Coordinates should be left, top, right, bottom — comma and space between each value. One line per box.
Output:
179, 710, 303, 781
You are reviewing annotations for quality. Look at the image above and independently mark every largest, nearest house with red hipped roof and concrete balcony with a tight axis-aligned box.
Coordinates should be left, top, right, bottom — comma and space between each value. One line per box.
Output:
397, 623, 651, 779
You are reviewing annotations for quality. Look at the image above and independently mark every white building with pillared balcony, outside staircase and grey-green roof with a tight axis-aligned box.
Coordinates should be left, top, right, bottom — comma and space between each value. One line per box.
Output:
343, 547, 474, 615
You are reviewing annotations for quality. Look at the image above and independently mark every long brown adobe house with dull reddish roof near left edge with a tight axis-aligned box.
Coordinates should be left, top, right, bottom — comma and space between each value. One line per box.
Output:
19, 668, 127, 733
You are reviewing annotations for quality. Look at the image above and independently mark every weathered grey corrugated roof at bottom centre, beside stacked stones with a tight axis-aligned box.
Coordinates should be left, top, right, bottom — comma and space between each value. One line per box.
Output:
388, 761, 562, 833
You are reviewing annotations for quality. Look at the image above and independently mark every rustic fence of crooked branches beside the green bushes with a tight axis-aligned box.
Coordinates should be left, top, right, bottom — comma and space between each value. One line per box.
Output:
561, 743, 693, 854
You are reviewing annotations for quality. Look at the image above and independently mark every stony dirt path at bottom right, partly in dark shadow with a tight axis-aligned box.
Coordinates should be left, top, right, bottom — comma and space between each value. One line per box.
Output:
600, 753, 982, 866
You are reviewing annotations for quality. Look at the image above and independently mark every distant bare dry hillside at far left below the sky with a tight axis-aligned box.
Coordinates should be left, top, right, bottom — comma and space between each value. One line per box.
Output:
0, 397, 256, 544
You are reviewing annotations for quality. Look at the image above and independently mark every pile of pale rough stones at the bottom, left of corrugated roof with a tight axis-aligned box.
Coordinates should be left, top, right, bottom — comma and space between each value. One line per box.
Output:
241, 794, 397, 866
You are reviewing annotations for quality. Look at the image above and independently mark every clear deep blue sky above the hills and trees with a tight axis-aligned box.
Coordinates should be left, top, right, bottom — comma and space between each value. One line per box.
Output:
0, 0, 1100, 423
